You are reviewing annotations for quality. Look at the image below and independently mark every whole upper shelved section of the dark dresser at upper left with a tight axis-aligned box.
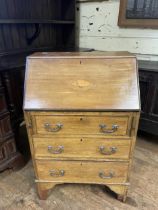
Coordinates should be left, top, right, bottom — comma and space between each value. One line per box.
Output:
0, 0, 75, 68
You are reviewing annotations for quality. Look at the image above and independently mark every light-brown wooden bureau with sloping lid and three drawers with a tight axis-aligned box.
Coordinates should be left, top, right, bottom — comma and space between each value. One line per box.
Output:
24, 52, 140, 201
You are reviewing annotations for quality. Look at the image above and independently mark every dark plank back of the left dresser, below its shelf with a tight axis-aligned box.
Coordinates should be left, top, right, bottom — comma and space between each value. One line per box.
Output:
0, 24, 58, 55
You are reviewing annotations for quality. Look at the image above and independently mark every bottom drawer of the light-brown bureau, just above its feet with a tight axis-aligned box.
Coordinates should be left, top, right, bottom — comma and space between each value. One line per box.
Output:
36, 160, 128, 183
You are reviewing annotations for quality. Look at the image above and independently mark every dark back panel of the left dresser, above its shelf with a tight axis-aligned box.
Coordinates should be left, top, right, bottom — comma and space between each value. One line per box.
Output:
0, 0, 75, 20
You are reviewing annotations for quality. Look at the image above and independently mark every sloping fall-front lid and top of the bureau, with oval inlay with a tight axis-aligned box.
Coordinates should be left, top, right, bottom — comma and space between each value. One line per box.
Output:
24, 52, 140, 111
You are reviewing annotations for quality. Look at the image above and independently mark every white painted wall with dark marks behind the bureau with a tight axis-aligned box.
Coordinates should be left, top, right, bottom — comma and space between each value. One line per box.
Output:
77, 0, 158, 60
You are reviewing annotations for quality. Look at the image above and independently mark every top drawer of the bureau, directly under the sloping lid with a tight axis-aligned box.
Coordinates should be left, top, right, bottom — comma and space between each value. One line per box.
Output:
31, 112, 132, 137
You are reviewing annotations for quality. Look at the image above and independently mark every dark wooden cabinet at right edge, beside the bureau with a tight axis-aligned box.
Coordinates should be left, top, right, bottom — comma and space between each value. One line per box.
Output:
139, 61, 158, 135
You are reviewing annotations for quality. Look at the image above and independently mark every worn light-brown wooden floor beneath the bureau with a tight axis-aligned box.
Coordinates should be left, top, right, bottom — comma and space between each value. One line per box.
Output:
0, 137, 158, 210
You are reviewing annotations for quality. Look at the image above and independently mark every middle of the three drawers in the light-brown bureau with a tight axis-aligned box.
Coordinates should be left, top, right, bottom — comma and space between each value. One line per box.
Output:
33, 137, 131, 159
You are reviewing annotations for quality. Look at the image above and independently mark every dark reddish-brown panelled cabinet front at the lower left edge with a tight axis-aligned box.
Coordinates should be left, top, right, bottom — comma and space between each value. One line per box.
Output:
0, 78, 24, 171
